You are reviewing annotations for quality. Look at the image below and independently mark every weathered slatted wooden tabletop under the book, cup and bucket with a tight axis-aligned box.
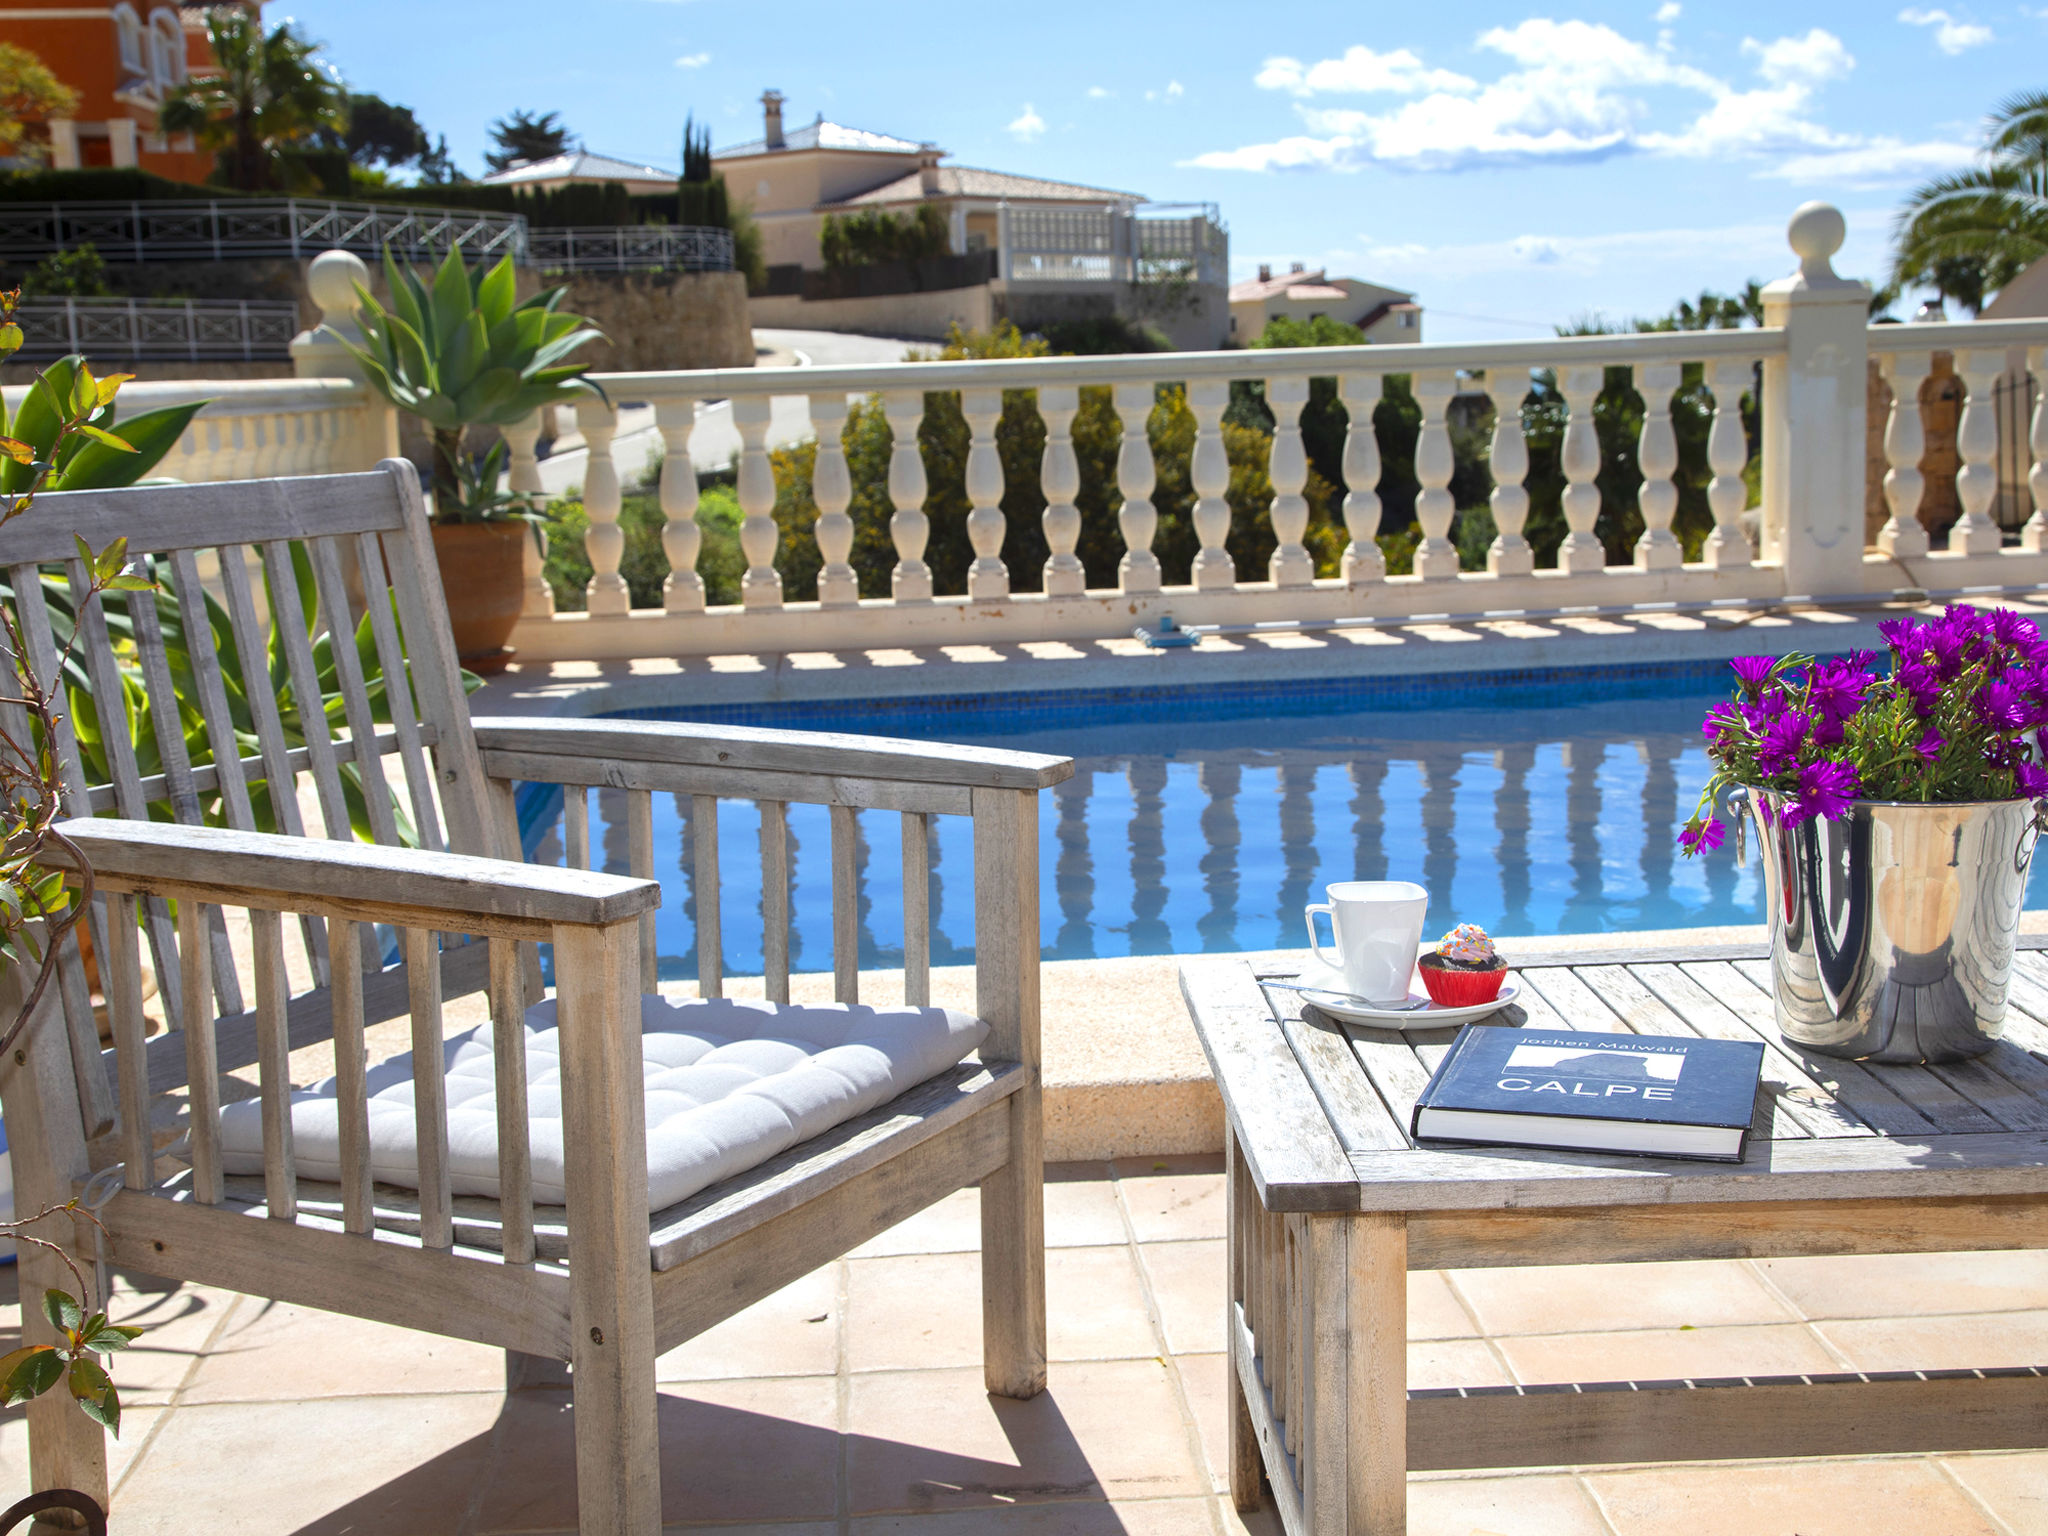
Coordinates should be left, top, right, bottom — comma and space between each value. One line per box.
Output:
1182, 940, 2048, 1210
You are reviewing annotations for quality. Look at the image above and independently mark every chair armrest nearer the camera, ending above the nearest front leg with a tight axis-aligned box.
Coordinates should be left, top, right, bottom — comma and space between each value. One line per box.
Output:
51, 817, 662, 938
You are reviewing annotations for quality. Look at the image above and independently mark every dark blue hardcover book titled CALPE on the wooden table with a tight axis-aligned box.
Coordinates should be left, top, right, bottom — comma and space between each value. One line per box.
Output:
1409, 1024, 1763, 1163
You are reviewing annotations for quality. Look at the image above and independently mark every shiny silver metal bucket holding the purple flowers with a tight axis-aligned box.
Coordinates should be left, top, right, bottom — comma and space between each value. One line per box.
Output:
1747, 791, 2048, 1061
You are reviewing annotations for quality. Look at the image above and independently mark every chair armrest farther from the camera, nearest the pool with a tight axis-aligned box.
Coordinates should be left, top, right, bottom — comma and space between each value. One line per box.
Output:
475, 719, 1073, 788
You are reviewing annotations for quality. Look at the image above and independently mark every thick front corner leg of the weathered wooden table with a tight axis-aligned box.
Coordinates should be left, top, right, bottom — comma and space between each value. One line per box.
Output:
1300, 1212, 1407, 1536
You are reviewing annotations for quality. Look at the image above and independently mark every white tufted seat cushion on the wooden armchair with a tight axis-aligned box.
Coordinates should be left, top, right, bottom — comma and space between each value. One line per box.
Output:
221, 997, 987, 1210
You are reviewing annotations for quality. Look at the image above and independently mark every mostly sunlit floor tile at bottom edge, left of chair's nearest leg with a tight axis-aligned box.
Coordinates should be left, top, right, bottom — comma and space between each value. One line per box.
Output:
115, 1393, 498, 1536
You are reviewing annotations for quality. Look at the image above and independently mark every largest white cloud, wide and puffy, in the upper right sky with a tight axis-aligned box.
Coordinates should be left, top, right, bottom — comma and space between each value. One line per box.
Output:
1188, 18, 1958, 180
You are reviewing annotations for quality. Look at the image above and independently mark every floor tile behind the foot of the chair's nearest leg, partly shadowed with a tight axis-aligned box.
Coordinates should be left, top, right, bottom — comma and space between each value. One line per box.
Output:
471, 1376, 840, 1536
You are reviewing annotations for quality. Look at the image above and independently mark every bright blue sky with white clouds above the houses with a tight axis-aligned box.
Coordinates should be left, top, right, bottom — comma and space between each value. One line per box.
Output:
280, 0, 2048, 342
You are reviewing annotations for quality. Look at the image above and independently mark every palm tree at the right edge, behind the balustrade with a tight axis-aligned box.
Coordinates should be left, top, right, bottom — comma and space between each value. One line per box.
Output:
1892, 90, 2048, 313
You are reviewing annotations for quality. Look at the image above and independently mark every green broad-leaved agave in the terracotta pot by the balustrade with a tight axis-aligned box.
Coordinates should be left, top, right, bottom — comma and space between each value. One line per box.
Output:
328, 250, 604, 522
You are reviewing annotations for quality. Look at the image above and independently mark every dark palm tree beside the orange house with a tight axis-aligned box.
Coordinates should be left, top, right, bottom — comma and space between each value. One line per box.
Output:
158, 6, 348, 193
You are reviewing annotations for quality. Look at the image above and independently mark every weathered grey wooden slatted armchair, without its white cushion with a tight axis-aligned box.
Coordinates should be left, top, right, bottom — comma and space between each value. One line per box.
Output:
0, 461, 1071, 1536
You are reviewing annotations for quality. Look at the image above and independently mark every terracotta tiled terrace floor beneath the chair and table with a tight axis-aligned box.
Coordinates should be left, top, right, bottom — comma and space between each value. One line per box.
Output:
0, 1159, 2048, 1536
